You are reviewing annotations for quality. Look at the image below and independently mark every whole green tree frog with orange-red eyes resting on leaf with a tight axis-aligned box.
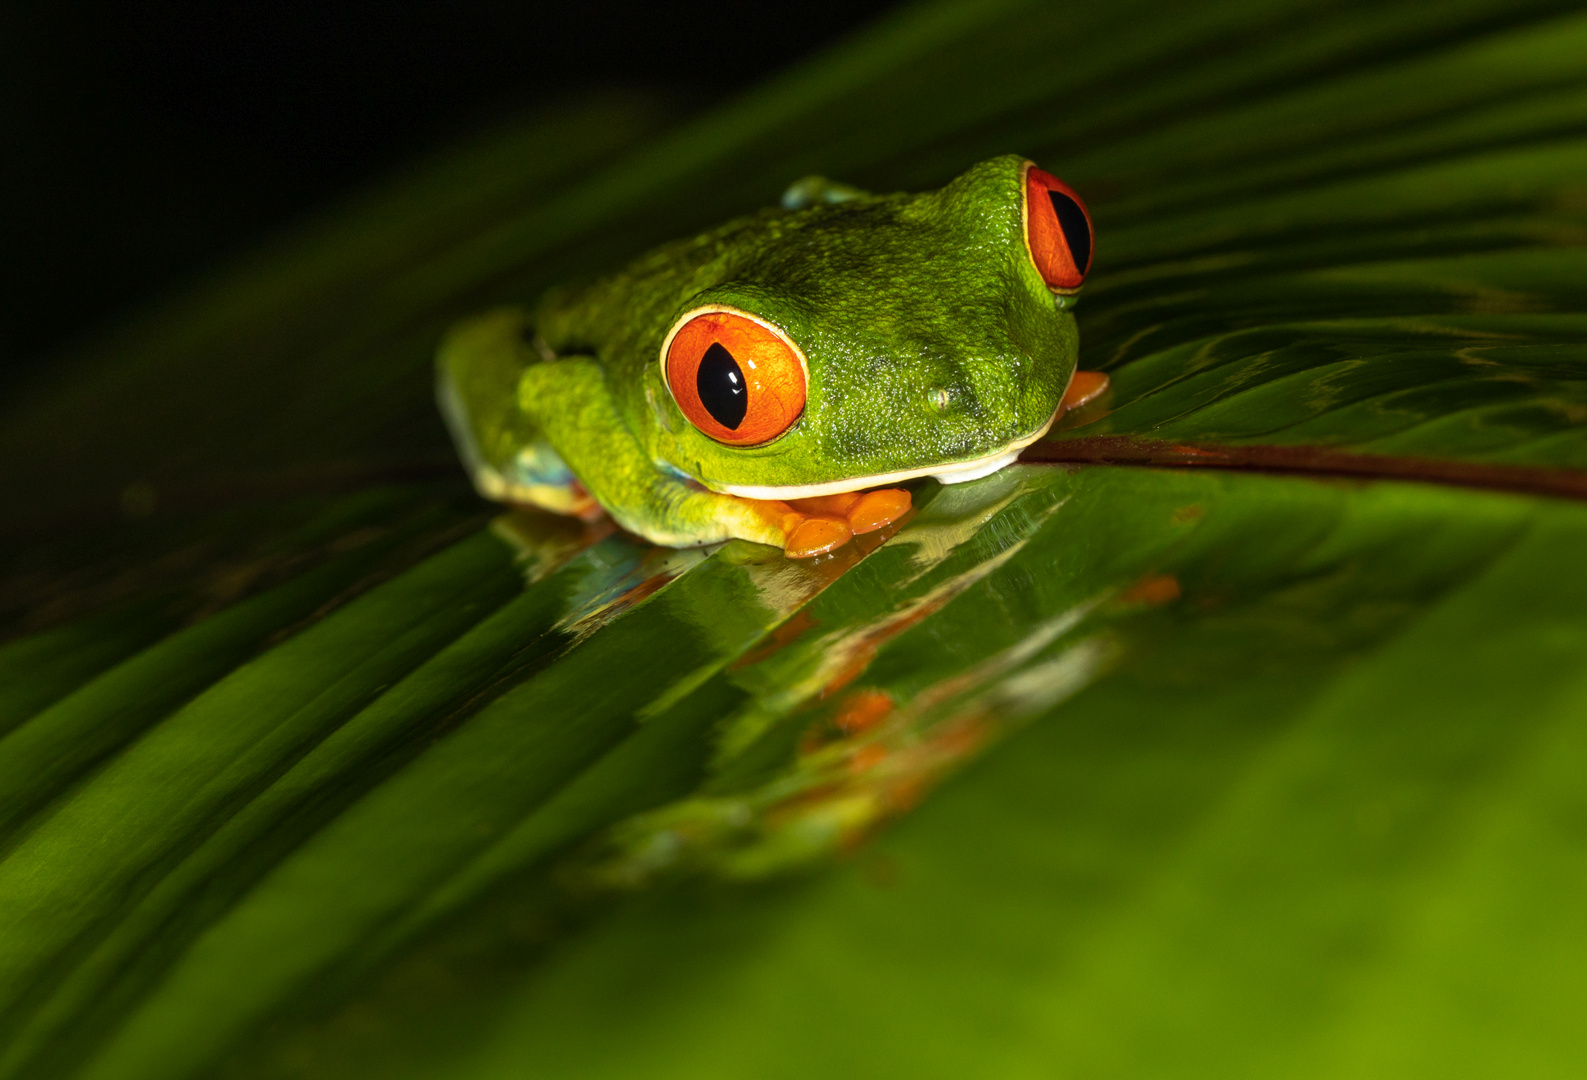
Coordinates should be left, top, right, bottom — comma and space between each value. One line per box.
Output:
438, 155, 1097, 557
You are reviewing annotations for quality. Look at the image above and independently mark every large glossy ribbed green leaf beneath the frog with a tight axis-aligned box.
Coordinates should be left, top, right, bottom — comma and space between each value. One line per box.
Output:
0, 0, 1587, 1080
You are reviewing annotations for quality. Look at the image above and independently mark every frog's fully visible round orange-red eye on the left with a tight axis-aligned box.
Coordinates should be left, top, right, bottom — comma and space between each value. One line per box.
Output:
662, 308, 808, 446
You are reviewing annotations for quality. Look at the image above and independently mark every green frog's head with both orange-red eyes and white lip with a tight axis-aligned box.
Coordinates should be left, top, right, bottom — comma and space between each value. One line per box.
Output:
646, 155, 1093, 498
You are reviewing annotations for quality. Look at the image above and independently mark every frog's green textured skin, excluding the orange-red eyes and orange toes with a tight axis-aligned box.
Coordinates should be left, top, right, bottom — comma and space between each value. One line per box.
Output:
441, 155, 1079, 544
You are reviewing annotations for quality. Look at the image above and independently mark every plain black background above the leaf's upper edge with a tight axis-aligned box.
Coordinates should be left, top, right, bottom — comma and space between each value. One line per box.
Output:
0, 0, 897, 374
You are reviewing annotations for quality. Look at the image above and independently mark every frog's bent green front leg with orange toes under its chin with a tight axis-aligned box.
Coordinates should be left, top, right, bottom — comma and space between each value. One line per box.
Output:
517, 357, 909, 558
